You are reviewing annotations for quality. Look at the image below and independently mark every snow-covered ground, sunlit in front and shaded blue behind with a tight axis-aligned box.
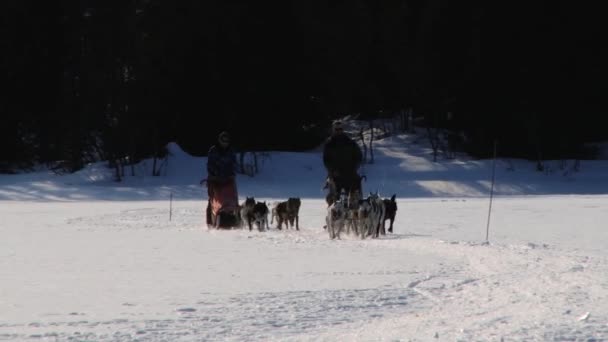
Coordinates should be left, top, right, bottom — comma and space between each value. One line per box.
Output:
0, 135, 608, 341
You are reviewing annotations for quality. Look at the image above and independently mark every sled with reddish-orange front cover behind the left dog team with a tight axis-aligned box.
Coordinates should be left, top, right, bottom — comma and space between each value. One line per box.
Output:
201, 179, 241, 229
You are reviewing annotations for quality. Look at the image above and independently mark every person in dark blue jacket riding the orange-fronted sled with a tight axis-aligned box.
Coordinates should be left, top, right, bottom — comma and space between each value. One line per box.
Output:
207, 131, 238, 225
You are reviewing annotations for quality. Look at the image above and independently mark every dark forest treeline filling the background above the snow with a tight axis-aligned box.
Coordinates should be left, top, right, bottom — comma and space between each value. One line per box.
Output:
0, 0, 608, 174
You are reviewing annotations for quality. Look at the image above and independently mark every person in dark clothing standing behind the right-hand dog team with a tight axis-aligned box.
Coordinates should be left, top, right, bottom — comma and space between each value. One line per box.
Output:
323, 121, 363, 200
